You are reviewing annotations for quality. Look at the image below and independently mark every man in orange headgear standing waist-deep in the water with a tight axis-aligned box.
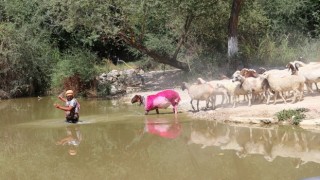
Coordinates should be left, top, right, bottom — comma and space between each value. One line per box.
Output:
54, 90, 80, 123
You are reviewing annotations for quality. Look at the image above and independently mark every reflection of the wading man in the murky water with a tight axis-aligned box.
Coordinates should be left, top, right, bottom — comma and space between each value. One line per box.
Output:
56, 126, 82, 156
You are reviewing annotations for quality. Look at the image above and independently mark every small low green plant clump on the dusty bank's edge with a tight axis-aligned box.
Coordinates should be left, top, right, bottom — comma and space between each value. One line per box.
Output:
276, 108, 309, 125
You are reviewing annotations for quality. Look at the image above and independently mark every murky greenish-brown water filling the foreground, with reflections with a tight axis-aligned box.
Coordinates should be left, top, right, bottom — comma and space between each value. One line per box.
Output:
0, 97, 320, 180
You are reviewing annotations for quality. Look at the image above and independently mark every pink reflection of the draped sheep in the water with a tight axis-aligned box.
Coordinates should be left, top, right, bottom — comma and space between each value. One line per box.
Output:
145, 119, 182, 139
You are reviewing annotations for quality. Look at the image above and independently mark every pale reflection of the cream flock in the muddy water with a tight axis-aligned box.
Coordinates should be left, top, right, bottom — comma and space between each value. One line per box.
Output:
189, 121, 320, 168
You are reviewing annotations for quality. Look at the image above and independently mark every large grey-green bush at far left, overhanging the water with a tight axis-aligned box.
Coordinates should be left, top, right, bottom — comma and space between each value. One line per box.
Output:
0, 23, 56, 95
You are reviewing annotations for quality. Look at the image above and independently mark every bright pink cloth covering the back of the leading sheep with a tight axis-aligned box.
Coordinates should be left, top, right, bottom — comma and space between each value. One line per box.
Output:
145, 89, 180, 111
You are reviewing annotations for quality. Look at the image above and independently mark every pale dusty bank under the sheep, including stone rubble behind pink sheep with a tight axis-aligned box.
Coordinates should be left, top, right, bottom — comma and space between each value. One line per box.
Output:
124, 71, 320, 129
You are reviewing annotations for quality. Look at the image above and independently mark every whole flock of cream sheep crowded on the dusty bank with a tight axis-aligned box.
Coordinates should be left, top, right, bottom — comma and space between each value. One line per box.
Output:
181, 61, 320, 111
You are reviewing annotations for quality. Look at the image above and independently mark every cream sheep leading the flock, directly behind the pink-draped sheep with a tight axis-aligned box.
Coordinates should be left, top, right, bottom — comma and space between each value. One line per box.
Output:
181, 82, 215, 111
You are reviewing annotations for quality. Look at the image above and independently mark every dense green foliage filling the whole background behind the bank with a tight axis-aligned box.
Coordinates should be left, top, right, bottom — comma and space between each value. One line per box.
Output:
0, 0, 320, 97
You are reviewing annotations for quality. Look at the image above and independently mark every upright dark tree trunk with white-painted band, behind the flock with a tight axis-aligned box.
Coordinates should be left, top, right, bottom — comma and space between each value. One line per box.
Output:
228, 0, 244, 70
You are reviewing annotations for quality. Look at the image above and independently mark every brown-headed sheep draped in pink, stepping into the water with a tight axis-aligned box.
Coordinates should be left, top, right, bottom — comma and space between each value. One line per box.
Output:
131, 89, 180, 115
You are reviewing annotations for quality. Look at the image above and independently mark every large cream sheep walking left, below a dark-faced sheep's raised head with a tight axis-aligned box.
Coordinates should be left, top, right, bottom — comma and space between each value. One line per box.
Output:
263, 63, 305, 104
